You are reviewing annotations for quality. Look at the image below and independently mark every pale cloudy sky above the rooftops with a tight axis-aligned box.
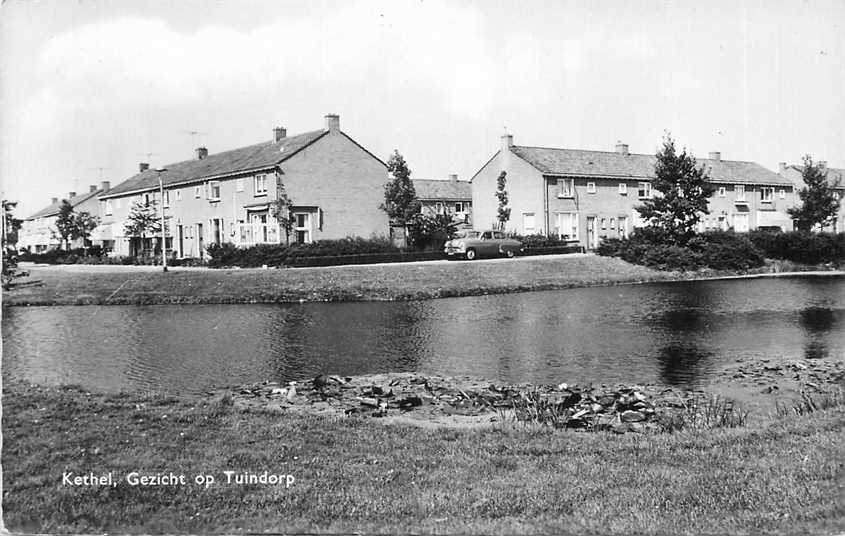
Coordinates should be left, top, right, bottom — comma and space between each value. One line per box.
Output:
0, 0, 845, 217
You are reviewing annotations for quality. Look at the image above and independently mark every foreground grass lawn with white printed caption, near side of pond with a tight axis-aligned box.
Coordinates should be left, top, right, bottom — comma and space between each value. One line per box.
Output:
2, 383, 845, 534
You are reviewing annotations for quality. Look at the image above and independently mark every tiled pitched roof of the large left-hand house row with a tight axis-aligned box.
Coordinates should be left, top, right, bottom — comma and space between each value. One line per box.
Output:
102, 130, 328, 198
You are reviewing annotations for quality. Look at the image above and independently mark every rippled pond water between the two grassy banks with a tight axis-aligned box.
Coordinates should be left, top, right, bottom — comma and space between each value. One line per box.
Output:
2, 277, 845, 392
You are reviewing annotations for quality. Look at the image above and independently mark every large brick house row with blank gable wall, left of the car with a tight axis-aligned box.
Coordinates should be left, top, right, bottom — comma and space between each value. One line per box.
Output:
100, 114, 388, 257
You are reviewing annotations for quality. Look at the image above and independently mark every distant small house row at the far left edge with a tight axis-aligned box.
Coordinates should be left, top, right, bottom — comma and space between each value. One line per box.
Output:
16, 181, 109, 253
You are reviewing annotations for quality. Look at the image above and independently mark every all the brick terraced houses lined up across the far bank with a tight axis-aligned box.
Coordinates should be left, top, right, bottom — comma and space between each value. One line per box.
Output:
18, 114, 845, 257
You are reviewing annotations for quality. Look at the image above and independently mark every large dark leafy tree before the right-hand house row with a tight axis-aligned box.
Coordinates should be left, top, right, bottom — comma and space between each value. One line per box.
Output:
635, 134, 715, 246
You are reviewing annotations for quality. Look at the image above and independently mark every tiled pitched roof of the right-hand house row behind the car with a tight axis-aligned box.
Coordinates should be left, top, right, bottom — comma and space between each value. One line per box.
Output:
511, 145, 792, 185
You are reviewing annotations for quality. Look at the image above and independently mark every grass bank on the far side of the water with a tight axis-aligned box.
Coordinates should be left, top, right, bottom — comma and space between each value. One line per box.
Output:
3, 255, 678, 305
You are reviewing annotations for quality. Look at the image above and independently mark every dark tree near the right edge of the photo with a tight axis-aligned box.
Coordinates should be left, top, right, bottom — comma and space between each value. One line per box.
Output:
787, 155, 840, 231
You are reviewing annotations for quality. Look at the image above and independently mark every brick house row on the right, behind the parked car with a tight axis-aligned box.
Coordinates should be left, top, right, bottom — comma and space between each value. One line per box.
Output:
470, 134, 795, 249
